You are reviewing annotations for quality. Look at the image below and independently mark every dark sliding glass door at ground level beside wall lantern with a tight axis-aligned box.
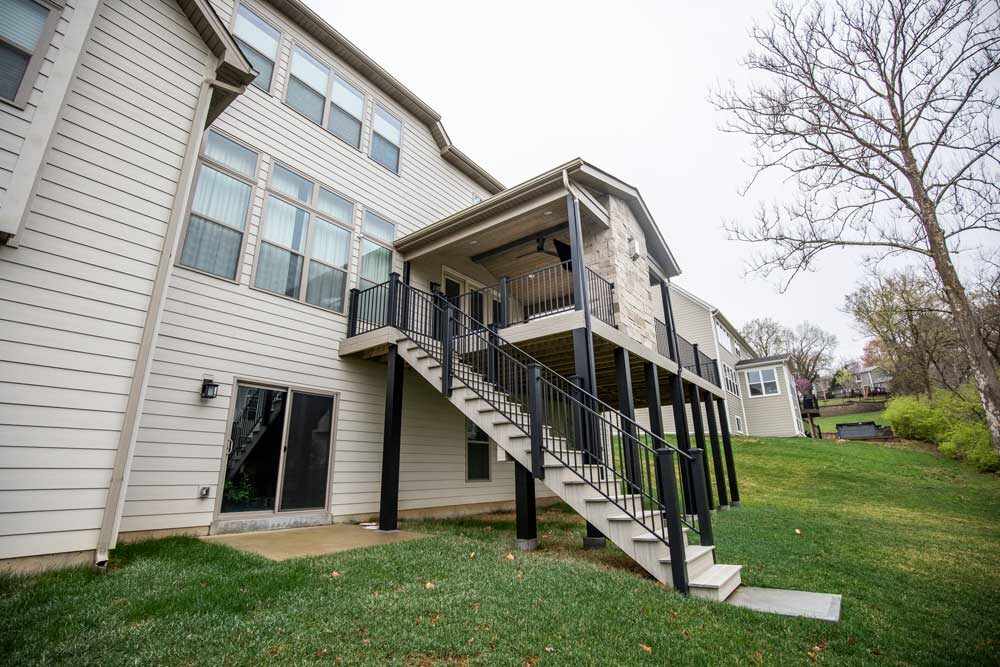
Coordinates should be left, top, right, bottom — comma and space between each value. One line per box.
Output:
221, 384, 335, 514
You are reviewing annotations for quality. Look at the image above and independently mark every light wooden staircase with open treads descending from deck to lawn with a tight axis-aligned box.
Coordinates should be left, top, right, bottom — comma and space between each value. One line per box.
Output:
394, 330, 741, 601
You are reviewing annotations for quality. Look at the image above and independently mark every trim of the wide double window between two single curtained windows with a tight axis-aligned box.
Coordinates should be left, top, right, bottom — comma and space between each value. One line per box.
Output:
250, 159, 361, 316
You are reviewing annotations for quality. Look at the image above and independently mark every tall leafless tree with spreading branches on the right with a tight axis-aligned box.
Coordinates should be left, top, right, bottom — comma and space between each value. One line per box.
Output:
713, 0, 1000, 451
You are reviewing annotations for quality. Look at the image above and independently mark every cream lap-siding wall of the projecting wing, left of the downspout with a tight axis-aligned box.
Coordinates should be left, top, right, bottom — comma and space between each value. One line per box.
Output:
0, 0, 215, 559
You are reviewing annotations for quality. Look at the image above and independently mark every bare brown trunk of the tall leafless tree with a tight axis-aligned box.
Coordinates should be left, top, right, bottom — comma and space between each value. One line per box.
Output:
920, 201, 1000, 453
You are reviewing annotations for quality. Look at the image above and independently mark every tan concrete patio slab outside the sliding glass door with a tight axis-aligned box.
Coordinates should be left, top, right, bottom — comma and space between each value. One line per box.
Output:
201, 524, 430, 560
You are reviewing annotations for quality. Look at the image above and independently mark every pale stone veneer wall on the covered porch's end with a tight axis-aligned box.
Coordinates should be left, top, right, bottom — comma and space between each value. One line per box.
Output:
583, 196, 656, 349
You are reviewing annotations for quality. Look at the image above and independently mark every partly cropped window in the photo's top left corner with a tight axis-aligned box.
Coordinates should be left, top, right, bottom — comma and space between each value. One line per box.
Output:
0, 0, 62, 107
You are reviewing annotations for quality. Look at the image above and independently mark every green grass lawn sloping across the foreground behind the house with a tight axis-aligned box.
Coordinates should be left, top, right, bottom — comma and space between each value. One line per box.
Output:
0, 438, 1000, 667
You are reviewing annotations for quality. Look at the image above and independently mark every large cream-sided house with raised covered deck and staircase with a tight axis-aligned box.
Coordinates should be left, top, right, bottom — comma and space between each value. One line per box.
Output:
0, 0, 748, 599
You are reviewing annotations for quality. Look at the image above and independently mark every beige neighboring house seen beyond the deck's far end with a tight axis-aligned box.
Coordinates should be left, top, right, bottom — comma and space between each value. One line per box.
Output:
640, 283, 805, 436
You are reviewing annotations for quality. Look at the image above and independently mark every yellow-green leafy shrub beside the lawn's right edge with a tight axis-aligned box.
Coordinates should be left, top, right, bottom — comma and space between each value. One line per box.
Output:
885, 387, 1000, 472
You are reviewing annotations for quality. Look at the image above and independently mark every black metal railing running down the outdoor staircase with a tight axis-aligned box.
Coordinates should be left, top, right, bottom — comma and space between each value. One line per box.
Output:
351, 275, 713, 589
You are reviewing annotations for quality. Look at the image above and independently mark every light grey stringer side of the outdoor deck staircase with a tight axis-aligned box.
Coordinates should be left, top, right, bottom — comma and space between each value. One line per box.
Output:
395, 332, 741, 601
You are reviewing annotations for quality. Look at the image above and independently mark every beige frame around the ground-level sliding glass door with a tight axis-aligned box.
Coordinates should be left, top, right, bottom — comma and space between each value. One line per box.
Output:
214, 378, 340, 521
